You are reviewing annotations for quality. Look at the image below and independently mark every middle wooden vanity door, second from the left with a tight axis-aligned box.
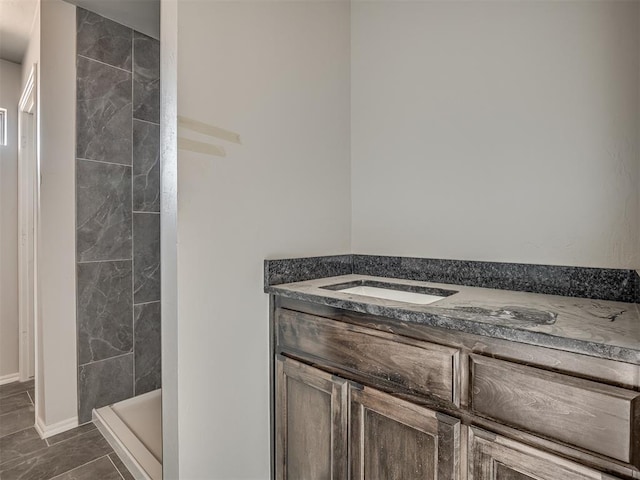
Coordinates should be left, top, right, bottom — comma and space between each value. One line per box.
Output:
349, 385, 460, 480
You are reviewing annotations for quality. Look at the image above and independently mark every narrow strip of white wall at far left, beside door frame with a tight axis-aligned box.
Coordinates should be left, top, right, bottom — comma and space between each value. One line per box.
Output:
0, 60, 21, 379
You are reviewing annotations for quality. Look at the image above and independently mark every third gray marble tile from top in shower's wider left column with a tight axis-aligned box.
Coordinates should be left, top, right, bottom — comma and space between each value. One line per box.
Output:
76, 160, 131, 262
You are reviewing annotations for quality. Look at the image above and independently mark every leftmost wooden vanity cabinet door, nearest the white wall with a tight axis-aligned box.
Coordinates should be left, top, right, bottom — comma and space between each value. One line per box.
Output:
275, 356, 348, 480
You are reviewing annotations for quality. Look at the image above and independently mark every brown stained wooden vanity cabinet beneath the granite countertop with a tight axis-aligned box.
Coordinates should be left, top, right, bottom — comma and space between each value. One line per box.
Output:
272, 299, 640, 480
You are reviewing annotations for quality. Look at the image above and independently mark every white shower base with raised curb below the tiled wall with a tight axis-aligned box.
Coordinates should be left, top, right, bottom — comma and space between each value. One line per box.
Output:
93, 389, 162, 480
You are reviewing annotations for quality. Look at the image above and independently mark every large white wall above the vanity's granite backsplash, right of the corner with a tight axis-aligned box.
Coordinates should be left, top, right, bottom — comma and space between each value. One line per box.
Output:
351, 1, 640, 268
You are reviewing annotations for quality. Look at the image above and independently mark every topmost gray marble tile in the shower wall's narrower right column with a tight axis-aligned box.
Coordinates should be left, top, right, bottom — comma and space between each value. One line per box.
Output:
133, 32, 160, 123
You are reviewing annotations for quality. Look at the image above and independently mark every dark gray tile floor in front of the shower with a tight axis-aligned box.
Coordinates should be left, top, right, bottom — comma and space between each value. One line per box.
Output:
0, 381, 133, 480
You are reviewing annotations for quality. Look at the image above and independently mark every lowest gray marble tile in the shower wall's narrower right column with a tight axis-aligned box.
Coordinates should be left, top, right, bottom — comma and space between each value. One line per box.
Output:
134, 302, 162, 395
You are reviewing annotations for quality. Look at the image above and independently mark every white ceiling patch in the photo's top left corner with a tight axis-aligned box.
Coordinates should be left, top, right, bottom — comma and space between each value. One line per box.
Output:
0, 0, 38, 63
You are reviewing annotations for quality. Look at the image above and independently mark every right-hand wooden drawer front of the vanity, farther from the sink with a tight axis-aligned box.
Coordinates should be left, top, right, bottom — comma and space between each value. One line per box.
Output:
470, 355, 640, 466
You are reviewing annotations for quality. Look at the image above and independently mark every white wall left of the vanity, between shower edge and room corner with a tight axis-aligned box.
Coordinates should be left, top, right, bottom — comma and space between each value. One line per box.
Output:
172, 1, 350, 480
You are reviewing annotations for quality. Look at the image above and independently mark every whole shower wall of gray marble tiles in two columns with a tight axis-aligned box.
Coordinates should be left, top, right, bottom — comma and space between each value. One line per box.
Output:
76, 8, 161, 423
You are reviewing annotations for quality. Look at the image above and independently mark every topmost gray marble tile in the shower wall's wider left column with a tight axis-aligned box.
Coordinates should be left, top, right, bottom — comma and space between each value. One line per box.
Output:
76, 8, 132, 71
